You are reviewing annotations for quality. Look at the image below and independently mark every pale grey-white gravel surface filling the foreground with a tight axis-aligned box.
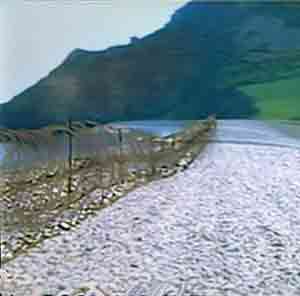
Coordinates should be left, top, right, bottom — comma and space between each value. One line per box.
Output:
1, 144, 300, 296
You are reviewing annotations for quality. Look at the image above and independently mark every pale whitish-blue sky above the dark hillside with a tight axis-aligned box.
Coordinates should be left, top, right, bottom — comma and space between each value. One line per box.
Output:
0, 0, 188, 102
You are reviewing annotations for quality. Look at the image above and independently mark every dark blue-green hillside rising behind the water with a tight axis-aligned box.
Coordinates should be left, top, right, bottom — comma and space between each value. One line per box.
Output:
0, 1, 300, 127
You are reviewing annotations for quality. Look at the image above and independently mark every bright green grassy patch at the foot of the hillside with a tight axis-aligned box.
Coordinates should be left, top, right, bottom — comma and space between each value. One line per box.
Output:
239, 78, 300, 119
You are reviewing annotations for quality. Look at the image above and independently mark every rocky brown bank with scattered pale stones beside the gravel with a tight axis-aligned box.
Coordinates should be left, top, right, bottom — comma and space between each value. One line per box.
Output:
0, 119, 216, 265
